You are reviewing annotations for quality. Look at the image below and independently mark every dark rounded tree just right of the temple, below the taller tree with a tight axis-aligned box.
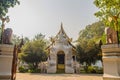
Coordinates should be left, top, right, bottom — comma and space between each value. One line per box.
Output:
77, 40, 101, 72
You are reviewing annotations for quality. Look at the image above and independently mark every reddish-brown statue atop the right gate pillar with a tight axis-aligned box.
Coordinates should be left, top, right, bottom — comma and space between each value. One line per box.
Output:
105, 27, 118, 44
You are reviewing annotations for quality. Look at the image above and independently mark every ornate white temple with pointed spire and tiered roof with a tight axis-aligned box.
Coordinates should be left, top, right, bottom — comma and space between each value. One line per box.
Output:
47, 23, 76, 73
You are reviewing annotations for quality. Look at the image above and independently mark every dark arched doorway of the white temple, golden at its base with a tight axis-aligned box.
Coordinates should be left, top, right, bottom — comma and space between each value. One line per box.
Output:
57, 51, 65, 73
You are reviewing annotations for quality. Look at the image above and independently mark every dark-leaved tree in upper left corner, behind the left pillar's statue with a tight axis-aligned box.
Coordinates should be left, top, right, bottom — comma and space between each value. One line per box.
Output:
0, 0, 20, 43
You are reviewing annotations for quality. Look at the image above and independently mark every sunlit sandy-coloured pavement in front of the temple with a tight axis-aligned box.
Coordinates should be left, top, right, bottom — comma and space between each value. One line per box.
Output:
16, 73, 103, 80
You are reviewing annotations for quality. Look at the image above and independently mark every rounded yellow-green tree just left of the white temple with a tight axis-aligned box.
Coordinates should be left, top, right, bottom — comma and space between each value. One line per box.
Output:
21, 33, 47, 69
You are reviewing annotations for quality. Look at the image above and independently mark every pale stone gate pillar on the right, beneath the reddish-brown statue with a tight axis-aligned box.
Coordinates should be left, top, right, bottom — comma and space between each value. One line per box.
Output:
101, 44, 120, 80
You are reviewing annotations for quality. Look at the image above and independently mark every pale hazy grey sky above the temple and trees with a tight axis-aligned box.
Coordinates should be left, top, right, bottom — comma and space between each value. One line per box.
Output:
6, 0, 98, 40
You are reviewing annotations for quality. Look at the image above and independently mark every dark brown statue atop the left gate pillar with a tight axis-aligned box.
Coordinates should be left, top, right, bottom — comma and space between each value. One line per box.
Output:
3, 28, 13, 44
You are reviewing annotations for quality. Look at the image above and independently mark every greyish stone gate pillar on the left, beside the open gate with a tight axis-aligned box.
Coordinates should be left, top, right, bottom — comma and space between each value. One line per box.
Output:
0, 44, 14, 80
